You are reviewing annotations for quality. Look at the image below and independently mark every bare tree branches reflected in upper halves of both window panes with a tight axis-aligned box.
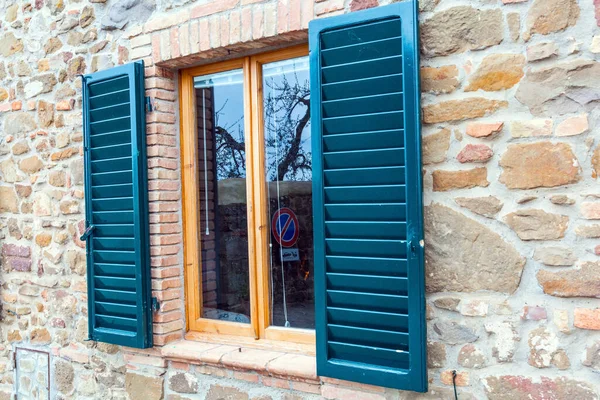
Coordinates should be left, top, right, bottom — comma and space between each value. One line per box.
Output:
215, 75, 312, 181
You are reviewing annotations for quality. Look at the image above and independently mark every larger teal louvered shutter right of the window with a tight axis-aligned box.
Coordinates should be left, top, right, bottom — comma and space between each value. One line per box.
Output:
309, 1, 427, 391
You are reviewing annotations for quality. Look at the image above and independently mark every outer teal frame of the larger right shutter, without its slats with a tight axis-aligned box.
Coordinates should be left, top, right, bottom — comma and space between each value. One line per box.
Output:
309, 0, 427, 392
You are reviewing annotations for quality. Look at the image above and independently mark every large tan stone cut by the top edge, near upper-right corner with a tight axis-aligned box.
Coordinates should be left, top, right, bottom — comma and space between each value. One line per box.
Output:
523, 0, 579, 41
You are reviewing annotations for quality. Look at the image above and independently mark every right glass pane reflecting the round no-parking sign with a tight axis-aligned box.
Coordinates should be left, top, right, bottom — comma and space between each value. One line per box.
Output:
262, 57, 315, 329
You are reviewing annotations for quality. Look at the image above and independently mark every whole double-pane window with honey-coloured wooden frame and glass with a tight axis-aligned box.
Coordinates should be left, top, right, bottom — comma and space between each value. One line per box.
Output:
181, 45, 315, 343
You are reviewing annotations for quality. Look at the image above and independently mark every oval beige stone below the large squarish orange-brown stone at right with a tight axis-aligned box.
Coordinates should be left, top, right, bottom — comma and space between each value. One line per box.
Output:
505, 209, 569, 240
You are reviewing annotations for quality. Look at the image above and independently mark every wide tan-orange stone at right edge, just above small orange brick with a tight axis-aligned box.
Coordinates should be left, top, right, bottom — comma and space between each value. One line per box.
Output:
537, 261, 600, 298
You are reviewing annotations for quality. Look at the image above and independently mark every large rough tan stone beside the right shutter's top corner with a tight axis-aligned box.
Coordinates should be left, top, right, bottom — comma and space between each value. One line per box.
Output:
421, 6, 504, 56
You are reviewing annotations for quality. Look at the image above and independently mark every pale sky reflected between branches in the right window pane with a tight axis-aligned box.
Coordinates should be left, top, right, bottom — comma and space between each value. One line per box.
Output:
263, 57, 311, 181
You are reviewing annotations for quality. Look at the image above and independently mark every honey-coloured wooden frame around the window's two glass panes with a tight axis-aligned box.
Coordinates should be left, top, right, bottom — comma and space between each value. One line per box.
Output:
179, 44, 315, 346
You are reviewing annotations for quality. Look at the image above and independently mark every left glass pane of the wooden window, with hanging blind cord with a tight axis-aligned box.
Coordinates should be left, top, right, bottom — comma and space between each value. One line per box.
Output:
194, 70, 250, 323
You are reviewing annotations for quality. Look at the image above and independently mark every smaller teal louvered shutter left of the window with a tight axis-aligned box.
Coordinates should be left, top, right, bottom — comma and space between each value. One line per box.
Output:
82, 62, 152, 348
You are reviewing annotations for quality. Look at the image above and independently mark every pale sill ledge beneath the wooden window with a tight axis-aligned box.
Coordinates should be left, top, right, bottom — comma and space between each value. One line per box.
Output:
161, 338, 319, 383
